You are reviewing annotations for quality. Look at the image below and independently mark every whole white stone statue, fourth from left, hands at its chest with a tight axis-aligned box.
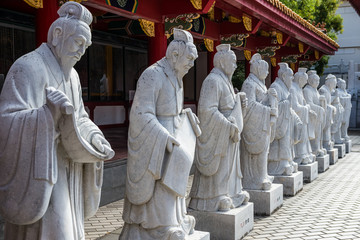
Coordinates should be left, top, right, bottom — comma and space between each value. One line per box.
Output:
240, 53, 278, 190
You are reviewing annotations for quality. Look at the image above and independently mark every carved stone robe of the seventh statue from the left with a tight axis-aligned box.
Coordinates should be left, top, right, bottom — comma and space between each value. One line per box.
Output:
303, 85, 326, 156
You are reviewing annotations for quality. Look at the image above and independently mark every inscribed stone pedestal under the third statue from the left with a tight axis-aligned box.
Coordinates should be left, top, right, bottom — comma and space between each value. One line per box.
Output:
188, 202, 254, 240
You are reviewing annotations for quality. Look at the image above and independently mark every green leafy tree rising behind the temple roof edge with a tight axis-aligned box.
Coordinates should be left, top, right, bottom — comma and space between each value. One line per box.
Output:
282, 0, 343, 75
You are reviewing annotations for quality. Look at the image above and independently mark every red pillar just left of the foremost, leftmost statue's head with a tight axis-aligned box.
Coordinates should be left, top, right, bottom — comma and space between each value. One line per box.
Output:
36, 0, 59, 46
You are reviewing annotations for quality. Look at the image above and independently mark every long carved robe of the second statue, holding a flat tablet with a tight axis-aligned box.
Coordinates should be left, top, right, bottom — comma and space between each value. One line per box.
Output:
120, 58, 195, 239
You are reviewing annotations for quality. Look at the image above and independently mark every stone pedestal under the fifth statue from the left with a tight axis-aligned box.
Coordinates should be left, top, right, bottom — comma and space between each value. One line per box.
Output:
274, 171, 304, 196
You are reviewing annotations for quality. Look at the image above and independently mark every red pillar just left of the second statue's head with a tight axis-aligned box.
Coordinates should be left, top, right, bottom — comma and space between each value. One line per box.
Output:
148, 23, 167, 66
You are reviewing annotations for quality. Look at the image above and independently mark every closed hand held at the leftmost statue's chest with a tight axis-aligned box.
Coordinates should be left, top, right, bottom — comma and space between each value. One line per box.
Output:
45, 87, 74, 124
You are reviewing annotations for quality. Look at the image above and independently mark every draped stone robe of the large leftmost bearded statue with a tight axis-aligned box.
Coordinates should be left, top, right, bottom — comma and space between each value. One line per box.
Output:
0, 43, 103, 240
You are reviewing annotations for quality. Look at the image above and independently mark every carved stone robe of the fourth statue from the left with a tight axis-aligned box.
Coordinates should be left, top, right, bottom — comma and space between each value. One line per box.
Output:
240, 73, 273, 190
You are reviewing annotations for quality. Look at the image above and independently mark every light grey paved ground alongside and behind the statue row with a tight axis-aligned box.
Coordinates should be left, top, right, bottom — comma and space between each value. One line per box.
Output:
85, 132, 360, 240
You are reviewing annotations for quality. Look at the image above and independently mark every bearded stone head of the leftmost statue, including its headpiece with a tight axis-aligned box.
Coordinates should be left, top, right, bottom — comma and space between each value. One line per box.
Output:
47, 2, 92, 67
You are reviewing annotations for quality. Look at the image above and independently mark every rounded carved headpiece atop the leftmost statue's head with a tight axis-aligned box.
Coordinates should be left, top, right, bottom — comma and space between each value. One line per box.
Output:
57, 1, 93, 25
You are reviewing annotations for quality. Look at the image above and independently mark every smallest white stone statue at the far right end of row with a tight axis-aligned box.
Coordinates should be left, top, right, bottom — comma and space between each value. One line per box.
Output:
336, 78, 352, 141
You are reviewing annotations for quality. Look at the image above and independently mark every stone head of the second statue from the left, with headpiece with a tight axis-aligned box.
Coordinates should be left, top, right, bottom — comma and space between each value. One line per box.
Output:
166, 28, 198, 78
